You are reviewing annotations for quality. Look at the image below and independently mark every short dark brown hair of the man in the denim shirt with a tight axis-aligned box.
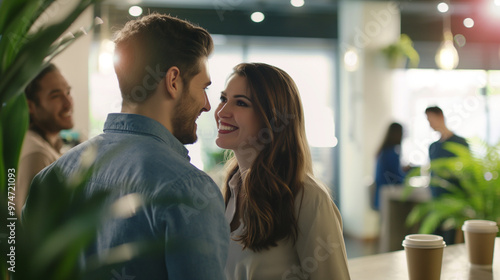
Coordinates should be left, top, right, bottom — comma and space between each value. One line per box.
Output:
115, 13, 213, 103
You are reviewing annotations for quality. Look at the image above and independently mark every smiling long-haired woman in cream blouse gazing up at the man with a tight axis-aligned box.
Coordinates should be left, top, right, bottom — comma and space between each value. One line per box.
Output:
215, 63, 350, 280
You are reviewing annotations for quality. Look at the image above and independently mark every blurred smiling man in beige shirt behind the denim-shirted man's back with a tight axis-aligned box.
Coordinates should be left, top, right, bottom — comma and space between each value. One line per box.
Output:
14, 64, 73, 216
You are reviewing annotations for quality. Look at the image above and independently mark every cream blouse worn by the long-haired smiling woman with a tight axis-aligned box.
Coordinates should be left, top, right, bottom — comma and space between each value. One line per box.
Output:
226, 172, 350, 280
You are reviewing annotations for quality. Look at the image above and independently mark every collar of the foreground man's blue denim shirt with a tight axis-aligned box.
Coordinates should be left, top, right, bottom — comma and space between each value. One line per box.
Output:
104, 113, 189, 160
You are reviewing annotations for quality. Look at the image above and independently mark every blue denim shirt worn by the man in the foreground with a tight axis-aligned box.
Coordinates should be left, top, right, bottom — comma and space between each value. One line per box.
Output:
25, 113, 229, 280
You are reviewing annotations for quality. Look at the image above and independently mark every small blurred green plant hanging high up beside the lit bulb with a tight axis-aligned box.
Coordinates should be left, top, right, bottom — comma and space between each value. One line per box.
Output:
382, 34, 420, 68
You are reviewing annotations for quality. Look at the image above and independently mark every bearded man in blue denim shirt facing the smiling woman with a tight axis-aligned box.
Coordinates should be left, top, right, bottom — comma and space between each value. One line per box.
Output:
23, 13, 229, 280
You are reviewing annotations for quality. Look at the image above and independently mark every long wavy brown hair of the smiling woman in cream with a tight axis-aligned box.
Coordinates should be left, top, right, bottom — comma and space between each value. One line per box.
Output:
224, 63, 312, 251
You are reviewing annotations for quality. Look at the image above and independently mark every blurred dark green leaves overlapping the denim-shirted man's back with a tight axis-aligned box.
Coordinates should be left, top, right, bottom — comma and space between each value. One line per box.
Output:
11, 143, 167, 280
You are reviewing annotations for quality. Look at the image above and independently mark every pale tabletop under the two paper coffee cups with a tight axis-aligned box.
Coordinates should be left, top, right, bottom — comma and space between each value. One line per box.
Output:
349, 238, 500, 280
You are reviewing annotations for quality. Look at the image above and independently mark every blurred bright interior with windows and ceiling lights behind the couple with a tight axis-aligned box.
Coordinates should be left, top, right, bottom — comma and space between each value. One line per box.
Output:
49, 0, 500, 256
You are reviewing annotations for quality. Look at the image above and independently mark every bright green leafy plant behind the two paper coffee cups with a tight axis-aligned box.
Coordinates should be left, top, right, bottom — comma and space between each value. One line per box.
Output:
406, 140, 500, 236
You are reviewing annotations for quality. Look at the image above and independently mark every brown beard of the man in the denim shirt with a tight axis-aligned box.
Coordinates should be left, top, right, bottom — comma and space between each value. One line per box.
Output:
172, 89, 200, 144
